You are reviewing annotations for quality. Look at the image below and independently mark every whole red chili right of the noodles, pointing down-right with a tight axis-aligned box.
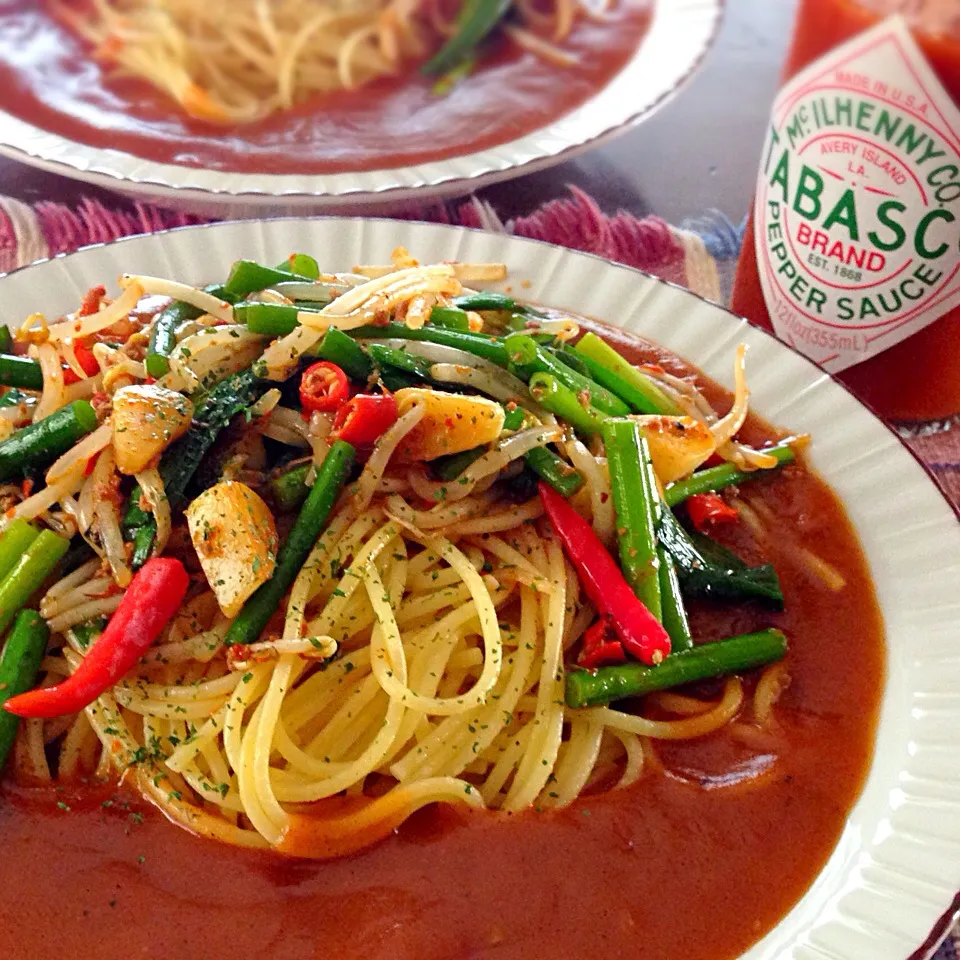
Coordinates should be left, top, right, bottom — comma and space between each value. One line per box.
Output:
538, 482, 670, 665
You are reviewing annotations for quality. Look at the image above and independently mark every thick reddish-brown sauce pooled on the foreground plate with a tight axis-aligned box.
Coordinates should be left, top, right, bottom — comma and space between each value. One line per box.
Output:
0, 330, 884, 960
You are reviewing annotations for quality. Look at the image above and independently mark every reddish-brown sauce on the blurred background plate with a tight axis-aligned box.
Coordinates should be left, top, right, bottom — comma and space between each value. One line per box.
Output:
0, 0, 649, 174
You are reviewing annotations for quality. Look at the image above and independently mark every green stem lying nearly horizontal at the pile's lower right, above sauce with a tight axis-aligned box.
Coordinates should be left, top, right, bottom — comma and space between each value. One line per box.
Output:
566, 630, 787, 708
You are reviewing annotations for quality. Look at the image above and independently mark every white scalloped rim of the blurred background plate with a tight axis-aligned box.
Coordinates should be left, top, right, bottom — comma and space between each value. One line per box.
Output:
0, 0, 723, 217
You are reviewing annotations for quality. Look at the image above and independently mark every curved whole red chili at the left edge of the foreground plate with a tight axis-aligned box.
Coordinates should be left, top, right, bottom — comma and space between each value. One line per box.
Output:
3, 557, 189, 718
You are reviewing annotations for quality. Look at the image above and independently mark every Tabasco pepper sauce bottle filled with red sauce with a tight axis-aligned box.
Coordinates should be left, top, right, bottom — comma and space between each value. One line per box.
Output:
732, 0, 960, 421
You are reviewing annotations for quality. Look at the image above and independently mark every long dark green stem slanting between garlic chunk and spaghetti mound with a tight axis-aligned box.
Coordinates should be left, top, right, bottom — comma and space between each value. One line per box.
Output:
225, 440, 356, 645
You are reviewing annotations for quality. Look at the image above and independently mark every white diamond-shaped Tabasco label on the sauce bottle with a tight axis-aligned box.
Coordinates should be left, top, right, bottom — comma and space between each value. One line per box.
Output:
755, 17, 960, 372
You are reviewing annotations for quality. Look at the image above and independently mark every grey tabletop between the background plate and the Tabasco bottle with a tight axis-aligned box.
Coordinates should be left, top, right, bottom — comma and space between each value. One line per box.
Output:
0, 0, 795, 224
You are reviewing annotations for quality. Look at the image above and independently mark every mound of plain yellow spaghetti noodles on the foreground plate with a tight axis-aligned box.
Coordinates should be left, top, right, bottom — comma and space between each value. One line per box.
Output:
28, 492, 763, 853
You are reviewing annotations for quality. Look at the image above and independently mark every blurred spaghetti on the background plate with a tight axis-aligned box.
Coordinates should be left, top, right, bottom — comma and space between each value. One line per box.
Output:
56, 0, 616, 124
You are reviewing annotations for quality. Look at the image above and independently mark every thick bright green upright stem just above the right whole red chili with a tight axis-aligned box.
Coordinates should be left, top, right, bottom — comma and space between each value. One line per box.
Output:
603, 418, 663, 621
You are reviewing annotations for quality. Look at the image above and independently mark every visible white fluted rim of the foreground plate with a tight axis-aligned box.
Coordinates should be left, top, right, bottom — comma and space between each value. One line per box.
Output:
0, 219, 960, 960
